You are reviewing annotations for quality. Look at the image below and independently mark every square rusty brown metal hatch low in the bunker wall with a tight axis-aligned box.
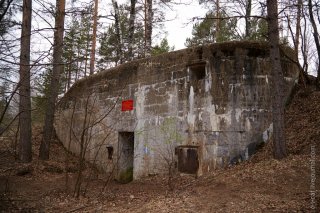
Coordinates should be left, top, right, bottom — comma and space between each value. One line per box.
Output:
176, 146, 199, 174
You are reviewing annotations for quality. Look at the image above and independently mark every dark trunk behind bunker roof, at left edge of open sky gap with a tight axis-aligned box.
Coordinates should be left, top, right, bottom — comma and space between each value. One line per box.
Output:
144, 0, 153, 57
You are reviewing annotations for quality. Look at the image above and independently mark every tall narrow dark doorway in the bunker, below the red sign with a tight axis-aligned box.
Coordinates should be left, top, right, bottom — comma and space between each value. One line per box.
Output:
118, 132, 134, 183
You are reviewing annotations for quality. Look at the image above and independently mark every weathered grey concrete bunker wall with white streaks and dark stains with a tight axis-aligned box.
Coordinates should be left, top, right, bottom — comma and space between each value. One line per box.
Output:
55, 42, 297, 178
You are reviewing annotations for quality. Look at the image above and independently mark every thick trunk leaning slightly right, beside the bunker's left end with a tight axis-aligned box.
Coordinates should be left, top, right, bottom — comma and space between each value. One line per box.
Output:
39, 0, 65, 160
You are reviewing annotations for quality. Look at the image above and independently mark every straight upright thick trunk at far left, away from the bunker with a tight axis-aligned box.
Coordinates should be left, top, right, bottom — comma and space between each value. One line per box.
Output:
19, 0, 32, 163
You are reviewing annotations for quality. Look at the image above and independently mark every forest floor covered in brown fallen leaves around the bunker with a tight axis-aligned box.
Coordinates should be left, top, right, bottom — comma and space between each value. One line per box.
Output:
0, 83, 320, 213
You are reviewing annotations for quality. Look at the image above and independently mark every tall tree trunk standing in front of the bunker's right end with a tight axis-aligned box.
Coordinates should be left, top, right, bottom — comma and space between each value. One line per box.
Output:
267, 0, 287, 159
